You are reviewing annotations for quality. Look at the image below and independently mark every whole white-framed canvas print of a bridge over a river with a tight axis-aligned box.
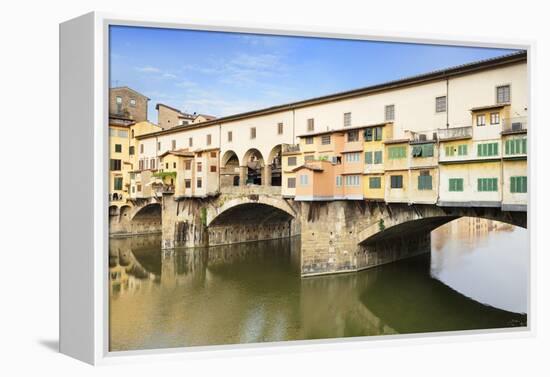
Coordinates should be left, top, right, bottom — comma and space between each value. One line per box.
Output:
60, 13, 536, 363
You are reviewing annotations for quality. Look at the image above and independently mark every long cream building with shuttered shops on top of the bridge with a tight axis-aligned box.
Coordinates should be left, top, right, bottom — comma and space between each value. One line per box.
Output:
133, 52, 528, 210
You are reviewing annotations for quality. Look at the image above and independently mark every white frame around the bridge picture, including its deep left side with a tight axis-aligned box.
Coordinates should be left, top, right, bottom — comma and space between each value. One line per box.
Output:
60, 12, 537, 364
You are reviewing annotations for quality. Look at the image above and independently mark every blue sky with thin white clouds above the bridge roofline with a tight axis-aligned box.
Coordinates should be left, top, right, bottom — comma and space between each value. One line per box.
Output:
110, 26, 514, 122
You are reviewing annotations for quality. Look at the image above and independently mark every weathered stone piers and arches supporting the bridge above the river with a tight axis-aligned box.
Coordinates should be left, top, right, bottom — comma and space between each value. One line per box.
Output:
109, 191, 527, 276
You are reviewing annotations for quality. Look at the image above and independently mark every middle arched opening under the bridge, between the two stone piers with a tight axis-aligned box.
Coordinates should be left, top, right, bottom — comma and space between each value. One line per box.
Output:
208, 203, 294, 246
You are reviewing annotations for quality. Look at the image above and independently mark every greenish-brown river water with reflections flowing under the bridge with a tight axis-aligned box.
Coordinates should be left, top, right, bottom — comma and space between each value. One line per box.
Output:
109, 218, 529, 351
